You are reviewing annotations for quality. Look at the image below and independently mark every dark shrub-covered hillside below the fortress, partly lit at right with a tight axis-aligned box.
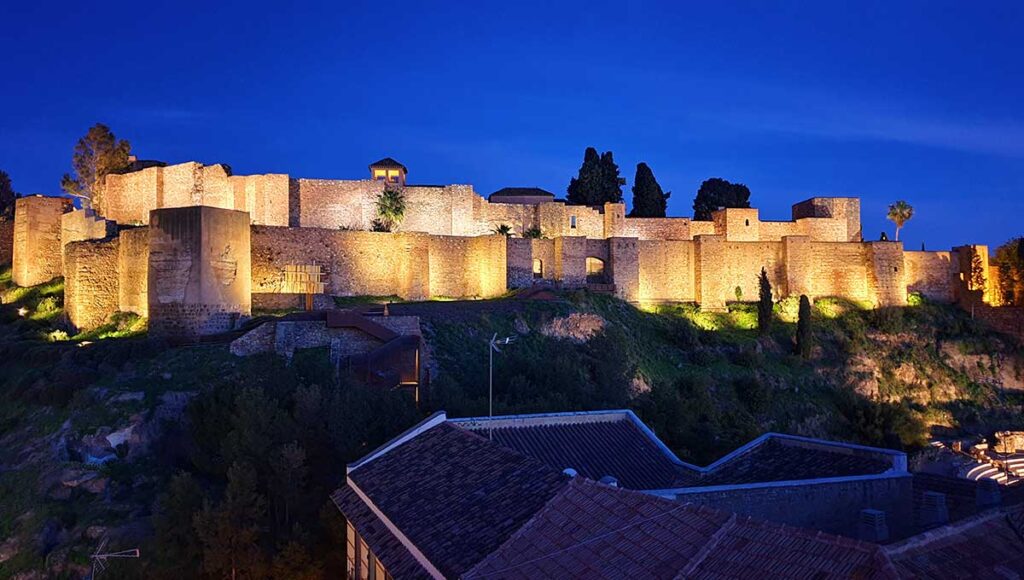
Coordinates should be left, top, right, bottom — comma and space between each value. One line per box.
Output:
0, 266, 1024, 579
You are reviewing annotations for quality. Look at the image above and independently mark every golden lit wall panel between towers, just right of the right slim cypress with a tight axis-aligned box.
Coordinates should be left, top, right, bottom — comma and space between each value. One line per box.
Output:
808, 242, 871, 300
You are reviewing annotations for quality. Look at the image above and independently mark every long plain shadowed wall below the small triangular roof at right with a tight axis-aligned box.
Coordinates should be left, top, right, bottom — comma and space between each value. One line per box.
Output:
676, 475, 913, 538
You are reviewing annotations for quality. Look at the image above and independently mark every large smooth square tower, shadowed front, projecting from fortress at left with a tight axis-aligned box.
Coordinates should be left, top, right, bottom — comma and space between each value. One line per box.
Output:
147, 206, 252, 338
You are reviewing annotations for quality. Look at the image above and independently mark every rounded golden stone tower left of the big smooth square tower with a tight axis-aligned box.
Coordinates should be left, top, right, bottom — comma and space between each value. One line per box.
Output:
65, 238, 119, 330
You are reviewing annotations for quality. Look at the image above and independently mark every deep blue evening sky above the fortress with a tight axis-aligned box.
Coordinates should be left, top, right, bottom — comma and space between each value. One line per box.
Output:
0, 0, 1024, 249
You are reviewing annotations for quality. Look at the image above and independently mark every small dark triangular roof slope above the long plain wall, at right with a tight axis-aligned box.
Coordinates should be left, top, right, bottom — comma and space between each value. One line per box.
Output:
695, 437, 892, 486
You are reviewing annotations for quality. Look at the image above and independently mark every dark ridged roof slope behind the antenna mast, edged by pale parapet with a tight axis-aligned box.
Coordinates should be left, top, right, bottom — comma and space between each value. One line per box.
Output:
450, 411, 685, 490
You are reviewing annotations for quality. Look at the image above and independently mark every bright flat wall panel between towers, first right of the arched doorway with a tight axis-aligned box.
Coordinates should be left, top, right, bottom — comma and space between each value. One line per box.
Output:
638, 240, 696, 302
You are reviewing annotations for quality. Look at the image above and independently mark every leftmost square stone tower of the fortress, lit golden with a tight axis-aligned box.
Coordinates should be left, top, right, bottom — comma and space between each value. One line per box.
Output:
11, 196, 68, 286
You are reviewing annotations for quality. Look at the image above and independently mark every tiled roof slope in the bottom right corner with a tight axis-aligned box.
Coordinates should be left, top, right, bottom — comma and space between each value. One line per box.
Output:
886, 511, 1024, 579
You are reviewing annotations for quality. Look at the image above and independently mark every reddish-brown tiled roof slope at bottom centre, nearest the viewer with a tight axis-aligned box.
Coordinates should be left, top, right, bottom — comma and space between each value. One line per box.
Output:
464, 479, 895, 578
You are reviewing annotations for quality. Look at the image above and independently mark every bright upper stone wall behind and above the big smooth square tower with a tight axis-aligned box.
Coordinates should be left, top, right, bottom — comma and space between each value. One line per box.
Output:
102, 162, 289, 225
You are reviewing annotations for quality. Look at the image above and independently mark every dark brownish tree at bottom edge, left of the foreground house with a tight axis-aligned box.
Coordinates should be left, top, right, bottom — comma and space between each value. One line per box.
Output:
193, 463, 266, 580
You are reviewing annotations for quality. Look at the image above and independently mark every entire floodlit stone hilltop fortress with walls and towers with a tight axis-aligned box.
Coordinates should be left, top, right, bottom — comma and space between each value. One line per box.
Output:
0, 159, 994, 337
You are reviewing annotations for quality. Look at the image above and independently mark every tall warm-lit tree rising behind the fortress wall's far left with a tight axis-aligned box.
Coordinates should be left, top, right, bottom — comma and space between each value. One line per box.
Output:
60, 123, 131, 209
